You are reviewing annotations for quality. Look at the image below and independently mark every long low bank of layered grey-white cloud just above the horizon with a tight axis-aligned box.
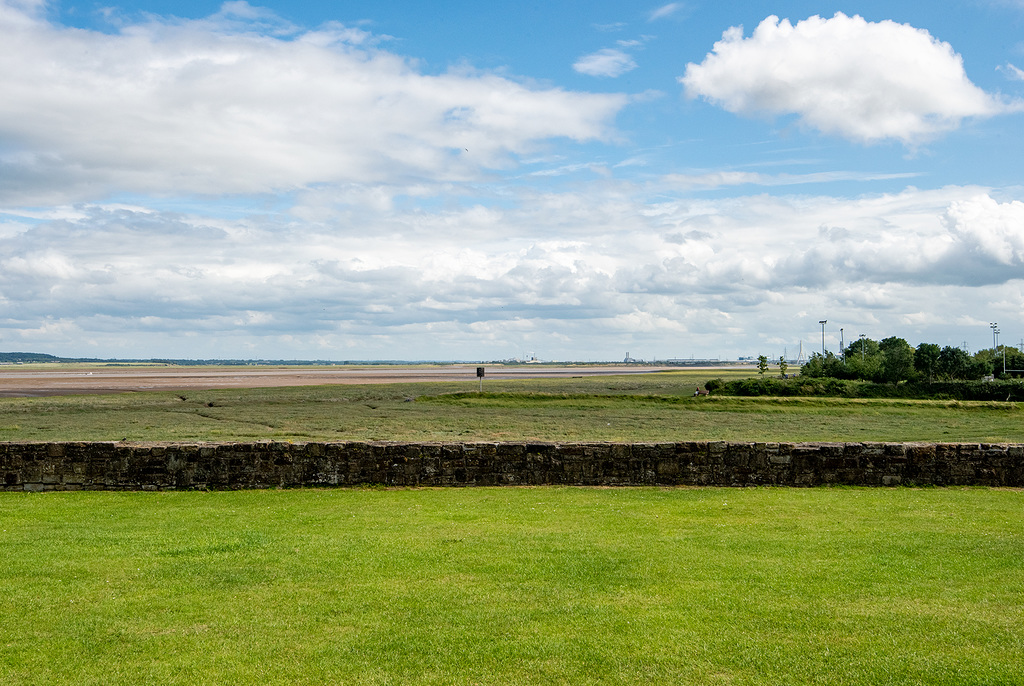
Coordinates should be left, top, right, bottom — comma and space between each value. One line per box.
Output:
0, 185, 1024, 359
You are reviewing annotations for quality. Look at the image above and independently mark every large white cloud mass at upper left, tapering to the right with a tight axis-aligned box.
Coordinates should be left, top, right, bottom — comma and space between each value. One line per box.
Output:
0, 0, 627, 206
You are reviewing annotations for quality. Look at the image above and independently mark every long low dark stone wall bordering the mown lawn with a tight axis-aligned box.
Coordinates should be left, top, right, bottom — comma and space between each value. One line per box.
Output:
0, 441, 1024, 490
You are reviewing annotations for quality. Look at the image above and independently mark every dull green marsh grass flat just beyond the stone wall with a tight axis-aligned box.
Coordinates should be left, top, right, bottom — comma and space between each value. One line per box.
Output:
0, 371, 1024, 442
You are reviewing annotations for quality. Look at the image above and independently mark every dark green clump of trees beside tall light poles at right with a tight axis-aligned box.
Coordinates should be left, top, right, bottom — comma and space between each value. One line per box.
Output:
798, 336, 1024, 383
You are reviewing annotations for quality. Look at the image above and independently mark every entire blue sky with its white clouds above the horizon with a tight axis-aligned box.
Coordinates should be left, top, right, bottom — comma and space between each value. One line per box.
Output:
0, 0, 1024, 360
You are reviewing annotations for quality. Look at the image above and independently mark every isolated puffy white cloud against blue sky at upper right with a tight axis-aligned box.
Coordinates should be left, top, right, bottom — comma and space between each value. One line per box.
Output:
679, 12, 1007, 144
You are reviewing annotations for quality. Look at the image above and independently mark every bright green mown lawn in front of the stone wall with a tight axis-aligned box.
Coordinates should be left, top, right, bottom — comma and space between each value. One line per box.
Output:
0, 488, 1024, 686
